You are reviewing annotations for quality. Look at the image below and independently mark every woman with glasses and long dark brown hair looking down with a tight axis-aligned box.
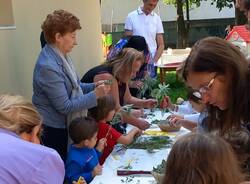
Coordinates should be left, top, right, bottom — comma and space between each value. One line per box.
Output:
183, 37, 250, 180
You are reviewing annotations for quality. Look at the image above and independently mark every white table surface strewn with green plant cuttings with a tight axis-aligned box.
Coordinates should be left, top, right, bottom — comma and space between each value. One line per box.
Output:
91, 111, 189, 184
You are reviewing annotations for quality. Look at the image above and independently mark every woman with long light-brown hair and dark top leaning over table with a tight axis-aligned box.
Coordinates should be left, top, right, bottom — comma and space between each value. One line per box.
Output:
81, 48, 156, 130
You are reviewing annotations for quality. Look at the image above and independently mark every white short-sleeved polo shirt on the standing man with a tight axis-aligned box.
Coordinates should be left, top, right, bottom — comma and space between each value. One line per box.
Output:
125, 7, 164, 57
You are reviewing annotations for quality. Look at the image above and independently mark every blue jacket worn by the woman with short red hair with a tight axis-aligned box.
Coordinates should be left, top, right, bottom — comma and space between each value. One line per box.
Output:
32, 45, 97, 129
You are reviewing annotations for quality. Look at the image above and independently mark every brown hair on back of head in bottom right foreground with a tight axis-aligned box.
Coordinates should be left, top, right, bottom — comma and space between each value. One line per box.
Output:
163, 133, 244, 184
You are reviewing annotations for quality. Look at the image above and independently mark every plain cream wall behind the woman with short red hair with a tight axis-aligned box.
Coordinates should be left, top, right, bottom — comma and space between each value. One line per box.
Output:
0, 0, 103, 99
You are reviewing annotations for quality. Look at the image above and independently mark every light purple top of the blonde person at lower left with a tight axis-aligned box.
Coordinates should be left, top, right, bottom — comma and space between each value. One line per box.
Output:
0, 128, 65, 184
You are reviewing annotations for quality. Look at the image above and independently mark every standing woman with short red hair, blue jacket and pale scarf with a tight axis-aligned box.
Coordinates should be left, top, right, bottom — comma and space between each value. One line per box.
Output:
32, 10, 110, 160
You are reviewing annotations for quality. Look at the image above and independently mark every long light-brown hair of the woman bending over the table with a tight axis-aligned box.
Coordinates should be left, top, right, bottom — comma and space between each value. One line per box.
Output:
106, 48, 144, 82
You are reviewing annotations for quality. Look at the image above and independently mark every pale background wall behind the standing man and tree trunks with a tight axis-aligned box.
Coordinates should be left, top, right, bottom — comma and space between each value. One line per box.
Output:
101, 0, 235, 24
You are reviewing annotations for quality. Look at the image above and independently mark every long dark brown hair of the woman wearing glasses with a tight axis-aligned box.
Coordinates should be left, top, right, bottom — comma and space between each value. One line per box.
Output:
183, 37, 250, 134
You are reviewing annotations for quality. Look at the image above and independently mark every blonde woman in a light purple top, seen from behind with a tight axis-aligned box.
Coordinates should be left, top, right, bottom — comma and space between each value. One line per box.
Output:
0, 95, 65, 184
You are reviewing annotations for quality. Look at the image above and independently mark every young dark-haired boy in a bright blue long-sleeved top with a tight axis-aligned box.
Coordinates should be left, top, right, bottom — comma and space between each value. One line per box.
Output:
66, 117, 106, 183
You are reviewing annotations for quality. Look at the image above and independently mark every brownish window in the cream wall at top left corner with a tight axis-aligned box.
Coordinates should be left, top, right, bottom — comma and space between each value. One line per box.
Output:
0, 0, 15, 29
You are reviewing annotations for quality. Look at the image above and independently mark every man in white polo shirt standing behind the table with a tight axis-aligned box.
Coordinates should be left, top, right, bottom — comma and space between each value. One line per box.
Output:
125, 0, 164, 77
